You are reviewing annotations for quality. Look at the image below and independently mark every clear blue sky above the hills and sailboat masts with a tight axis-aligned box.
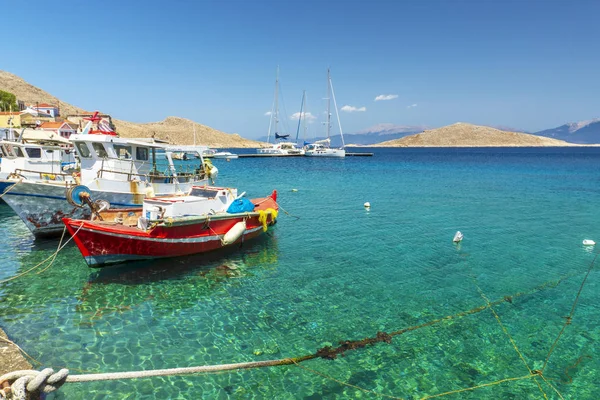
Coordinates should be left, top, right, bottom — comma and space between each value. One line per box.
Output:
0, 0, 600, 138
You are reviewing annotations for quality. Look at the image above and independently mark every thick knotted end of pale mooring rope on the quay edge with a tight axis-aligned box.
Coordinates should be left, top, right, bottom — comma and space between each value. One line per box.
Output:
0, 368, 69, 400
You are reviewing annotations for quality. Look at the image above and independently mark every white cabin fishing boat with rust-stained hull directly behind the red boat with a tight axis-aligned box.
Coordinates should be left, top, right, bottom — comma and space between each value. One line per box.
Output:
3, 114, 218, 236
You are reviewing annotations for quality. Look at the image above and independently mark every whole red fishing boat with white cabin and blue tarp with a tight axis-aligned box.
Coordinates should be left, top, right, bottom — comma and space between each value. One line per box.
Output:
63, 186, 279, 268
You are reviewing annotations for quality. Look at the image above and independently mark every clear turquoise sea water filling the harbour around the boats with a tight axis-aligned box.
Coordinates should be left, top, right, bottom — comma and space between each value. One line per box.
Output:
0, 148, 600, 400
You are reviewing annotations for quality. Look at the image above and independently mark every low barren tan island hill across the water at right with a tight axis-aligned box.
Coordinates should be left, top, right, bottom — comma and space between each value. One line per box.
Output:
372, 122, 573, 147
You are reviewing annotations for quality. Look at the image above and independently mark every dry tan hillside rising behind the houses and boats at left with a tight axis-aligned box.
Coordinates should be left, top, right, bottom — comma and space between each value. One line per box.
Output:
0, 71, 262, 148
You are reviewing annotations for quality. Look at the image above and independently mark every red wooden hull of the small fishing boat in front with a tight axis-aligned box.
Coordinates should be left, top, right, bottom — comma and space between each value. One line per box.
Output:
63, 197, 278, 268
